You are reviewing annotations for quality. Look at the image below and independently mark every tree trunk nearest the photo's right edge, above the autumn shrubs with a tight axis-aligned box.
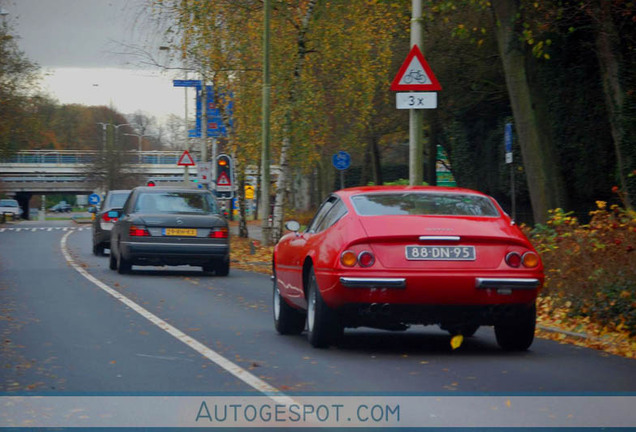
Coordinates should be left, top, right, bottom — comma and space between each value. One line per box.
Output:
593, 0, 632, 208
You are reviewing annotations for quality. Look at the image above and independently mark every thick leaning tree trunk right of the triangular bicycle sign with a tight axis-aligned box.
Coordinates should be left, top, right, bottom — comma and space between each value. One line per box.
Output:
492, 0, 564, 223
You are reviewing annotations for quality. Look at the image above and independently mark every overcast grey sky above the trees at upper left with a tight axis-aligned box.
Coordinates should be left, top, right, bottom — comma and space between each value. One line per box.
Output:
0, 0, 188, 121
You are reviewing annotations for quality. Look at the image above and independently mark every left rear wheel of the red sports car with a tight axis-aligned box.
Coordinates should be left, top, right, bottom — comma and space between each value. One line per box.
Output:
307, 268, 344, 348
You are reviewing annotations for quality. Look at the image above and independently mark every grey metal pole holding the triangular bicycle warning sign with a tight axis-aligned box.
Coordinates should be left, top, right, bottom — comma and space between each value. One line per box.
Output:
409, 0, 424, 186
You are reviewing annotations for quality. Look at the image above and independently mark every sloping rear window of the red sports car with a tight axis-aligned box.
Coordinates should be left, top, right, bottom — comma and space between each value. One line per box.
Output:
351, 192, 499, 217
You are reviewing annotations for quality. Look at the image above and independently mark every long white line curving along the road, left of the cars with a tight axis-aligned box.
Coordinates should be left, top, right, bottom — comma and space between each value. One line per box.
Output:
60, 231, 297, 405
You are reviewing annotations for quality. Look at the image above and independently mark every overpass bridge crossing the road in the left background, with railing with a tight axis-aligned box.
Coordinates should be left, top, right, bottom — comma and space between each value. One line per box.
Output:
0, 150, 199, 217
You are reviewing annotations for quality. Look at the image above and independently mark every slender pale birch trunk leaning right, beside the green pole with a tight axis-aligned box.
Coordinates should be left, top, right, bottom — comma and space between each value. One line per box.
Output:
272, 0, 318, 243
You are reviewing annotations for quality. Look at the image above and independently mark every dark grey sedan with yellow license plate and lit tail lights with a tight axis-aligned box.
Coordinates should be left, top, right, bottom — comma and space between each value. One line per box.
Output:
110, 187, 230, 276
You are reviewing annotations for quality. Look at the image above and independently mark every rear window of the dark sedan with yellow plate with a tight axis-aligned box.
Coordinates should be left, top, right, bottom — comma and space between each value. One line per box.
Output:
134, 192, 218, 213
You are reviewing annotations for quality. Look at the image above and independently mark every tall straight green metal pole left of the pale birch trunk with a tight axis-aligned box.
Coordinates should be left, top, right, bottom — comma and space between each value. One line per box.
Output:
259, 0, 272, 246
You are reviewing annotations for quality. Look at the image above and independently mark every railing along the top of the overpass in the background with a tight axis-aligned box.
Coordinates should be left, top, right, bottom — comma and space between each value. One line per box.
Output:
0, 150, 199, 165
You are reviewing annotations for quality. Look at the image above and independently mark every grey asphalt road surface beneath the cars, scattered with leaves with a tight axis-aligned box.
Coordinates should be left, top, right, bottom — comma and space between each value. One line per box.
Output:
0, 222, 636, 394
